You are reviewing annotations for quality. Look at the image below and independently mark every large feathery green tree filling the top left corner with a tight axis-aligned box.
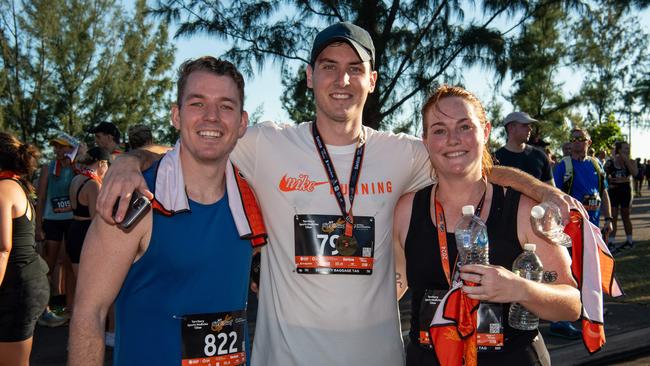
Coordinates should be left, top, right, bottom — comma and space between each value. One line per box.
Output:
0, 0, 174, 144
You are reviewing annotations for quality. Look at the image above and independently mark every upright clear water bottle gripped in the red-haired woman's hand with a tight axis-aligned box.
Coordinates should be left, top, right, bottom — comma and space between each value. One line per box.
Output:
455, 205, 490, 265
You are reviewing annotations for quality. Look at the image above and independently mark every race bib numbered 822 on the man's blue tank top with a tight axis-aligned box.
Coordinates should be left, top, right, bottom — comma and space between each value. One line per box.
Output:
181, 310, 246, 366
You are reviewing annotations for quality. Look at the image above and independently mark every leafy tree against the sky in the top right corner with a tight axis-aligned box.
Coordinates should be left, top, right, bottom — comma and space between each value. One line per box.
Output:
571, 0, 648, 123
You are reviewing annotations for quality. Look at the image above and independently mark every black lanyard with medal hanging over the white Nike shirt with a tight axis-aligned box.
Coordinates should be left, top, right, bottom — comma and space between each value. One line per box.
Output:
311, 121, 366, 237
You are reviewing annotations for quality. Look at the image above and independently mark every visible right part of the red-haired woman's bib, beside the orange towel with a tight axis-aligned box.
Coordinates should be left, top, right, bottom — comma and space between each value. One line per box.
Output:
476, 302, 505, 352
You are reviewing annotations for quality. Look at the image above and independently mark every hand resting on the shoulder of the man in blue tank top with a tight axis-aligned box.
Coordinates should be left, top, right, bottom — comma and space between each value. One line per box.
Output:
96, 154, 153, 224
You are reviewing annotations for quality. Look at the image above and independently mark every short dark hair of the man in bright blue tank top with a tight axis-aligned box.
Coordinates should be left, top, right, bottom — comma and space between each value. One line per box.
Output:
176, 56, 244, 111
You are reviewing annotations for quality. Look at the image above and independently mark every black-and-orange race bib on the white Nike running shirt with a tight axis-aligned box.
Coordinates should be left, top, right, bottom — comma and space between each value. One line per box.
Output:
294, 215, 375, 275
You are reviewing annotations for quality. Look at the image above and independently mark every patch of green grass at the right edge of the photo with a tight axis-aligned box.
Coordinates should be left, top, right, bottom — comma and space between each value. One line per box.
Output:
614, 240, 650, 304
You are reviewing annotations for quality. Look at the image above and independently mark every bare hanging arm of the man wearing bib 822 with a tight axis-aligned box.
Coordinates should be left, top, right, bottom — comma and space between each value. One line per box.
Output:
68, 212, 152, 366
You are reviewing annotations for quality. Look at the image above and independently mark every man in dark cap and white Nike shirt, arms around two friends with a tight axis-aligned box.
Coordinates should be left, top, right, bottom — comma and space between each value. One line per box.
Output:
98, 22, 584, 366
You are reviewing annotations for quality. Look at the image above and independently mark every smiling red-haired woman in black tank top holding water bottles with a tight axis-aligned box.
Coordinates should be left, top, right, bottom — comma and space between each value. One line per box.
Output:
393, 86, 581, 366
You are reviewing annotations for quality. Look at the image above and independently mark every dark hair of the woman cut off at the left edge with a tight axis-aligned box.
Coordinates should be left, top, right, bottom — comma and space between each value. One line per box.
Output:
0, 132, 40, 191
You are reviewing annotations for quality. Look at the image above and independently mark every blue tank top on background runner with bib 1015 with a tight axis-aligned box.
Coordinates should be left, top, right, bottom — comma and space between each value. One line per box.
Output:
43, 160, 74, 220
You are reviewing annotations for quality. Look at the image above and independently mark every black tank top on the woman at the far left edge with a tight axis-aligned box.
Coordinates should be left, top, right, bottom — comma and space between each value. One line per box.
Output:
0, 178, 48, 287
